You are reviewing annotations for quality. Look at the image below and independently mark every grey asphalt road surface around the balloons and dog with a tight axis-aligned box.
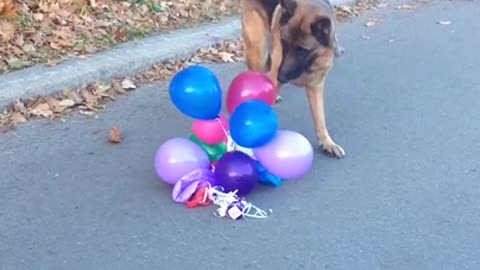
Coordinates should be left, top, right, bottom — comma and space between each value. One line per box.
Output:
0, 1, 480, 270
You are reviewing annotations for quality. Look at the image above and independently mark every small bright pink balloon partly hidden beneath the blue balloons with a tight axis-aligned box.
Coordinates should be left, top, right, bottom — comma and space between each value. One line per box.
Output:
192, 115, 229, 144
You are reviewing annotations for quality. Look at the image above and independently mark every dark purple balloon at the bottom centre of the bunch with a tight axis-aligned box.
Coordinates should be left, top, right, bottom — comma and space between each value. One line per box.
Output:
214, 151, 258, 197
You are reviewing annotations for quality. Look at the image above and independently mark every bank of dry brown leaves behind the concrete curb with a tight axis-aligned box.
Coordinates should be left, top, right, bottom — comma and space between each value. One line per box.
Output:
0, 0, 238, 74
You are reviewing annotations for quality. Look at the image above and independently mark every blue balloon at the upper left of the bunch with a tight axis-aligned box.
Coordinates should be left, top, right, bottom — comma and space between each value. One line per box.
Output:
169, 66, 222, 120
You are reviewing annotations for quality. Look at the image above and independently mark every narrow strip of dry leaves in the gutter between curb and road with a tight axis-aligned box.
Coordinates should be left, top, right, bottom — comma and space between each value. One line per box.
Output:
0, 41, 242, 130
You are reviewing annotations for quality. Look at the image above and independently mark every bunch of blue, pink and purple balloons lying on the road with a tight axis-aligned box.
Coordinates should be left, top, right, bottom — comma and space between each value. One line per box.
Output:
155, 65, 313, 215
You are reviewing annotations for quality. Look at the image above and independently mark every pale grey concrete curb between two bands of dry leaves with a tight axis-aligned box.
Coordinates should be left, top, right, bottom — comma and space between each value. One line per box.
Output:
0, 0, 355, 108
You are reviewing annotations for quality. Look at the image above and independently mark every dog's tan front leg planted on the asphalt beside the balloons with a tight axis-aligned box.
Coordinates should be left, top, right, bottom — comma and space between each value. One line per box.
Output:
305, 76, 345, 158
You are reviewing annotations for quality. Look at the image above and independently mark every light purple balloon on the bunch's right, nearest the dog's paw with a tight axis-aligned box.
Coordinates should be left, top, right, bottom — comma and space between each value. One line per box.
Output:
254, 130, 313, 179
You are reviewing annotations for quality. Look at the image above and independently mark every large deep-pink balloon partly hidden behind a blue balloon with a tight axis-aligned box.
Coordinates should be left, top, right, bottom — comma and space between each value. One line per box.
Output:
226, 71, 277, 114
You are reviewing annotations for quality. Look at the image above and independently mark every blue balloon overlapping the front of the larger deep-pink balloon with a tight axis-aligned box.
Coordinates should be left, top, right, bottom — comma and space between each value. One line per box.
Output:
230, 99, 278, 148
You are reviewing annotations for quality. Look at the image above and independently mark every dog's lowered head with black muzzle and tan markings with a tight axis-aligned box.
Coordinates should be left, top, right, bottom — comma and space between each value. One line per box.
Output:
278, 0, 335, 83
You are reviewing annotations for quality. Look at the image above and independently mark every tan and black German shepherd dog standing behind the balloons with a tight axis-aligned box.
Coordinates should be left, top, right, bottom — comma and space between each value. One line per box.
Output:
241, 0, 345, 158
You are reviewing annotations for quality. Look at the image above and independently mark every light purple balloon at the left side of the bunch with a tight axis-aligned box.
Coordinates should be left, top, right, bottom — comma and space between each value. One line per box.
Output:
155, 137, 210, 185
